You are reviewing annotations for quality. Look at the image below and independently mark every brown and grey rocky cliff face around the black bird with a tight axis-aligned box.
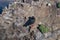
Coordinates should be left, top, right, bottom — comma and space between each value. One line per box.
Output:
0, 0, 60, 40
